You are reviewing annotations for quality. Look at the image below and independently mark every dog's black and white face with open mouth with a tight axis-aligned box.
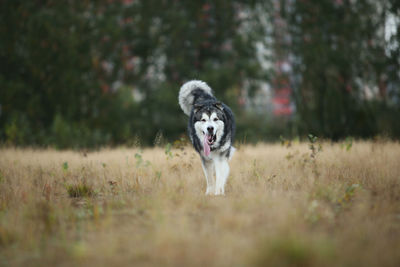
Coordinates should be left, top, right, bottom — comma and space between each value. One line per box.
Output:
194, 106, 225, 151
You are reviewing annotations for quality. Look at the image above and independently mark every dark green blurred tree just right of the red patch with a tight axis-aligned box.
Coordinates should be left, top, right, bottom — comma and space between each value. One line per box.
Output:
284, 0, 399, 139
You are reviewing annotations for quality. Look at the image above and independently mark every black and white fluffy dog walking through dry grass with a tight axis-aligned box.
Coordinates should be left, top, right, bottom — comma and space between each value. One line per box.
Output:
179, 80, 236, 195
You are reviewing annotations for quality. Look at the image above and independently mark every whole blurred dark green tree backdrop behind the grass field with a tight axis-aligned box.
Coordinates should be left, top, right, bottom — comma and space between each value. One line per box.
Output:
0, 0, 400, 148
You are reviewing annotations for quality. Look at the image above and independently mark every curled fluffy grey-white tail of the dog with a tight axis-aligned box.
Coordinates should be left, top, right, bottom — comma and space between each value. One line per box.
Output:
179, 80, 213, 116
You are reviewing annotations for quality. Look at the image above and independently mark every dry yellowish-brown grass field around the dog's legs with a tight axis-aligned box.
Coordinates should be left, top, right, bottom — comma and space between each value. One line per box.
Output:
0, 141, 400, 266
